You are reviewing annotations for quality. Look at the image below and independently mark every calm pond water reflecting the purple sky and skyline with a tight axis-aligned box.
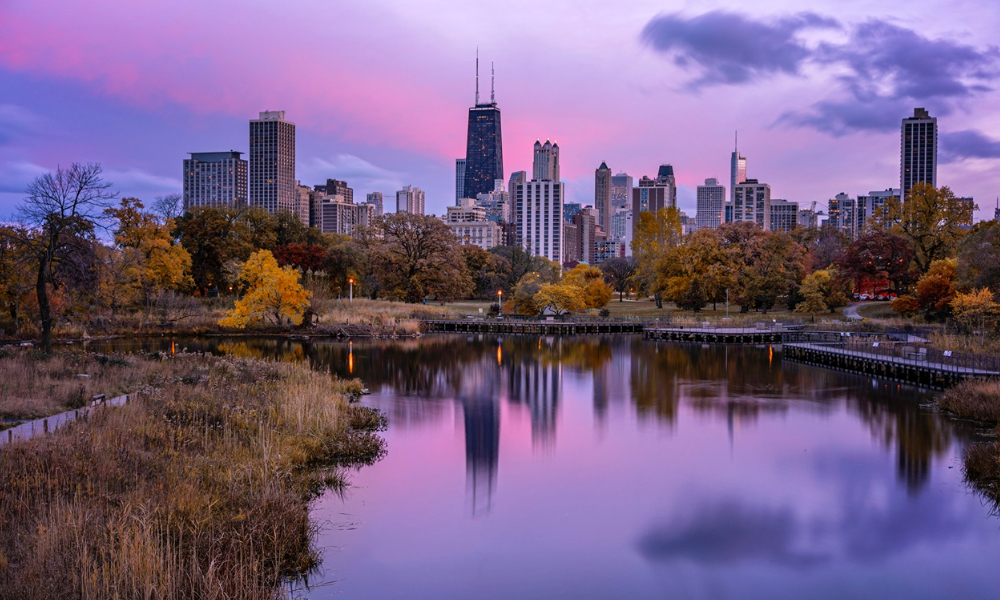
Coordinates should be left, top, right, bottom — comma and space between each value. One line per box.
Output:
97, 336, 1000, 599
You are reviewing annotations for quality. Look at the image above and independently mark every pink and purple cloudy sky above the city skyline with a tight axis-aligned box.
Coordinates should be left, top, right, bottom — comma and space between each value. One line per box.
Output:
0, 0, 1000, 218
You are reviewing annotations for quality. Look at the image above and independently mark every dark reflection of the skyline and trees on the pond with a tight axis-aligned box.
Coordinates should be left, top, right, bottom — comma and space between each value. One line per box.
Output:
96, 335, 970, 513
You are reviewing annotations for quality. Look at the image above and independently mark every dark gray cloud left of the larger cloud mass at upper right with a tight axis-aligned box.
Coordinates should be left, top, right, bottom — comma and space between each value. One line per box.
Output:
641, 11, 839, 88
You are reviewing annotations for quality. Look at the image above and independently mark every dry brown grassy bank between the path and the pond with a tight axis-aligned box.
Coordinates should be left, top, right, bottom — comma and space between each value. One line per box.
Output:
0, 354, 385, 599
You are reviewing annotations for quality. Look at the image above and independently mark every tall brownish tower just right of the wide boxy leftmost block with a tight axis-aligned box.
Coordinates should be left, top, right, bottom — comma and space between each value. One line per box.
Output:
249, 110, 299, 213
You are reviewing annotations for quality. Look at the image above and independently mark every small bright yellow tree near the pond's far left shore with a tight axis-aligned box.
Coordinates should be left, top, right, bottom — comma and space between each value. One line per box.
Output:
219, 250, 310, 328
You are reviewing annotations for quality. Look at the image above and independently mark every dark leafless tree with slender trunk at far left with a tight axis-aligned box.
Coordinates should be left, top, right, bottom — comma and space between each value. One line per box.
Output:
16, 163, 116, 352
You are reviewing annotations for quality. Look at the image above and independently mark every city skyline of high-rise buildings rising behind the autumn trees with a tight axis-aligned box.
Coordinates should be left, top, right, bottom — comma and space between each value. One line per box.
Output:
183, 57, 976, 266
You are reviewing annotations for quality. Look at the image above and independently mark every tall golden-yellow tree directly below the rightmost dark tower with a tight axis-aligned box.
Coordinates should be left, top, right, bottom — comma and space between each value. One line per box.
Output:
876, 183, 975, 273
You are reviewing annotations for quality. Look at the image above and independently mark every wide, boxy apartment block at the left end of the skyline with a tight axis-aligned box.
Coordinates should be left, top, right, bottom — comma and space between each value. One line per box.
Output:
183, 150, 247, 211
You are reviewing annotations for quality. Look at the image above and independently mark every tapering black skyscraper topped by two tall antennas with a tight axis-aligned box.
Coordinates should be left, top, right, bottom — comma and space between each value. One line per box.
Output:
464, 53, 503, 198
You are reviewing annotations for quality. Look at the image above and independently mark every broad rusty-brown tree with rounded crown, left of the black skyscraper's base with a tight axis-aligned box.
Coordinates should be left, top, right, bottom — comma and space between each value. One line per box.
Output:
362, 213, 473, 302
